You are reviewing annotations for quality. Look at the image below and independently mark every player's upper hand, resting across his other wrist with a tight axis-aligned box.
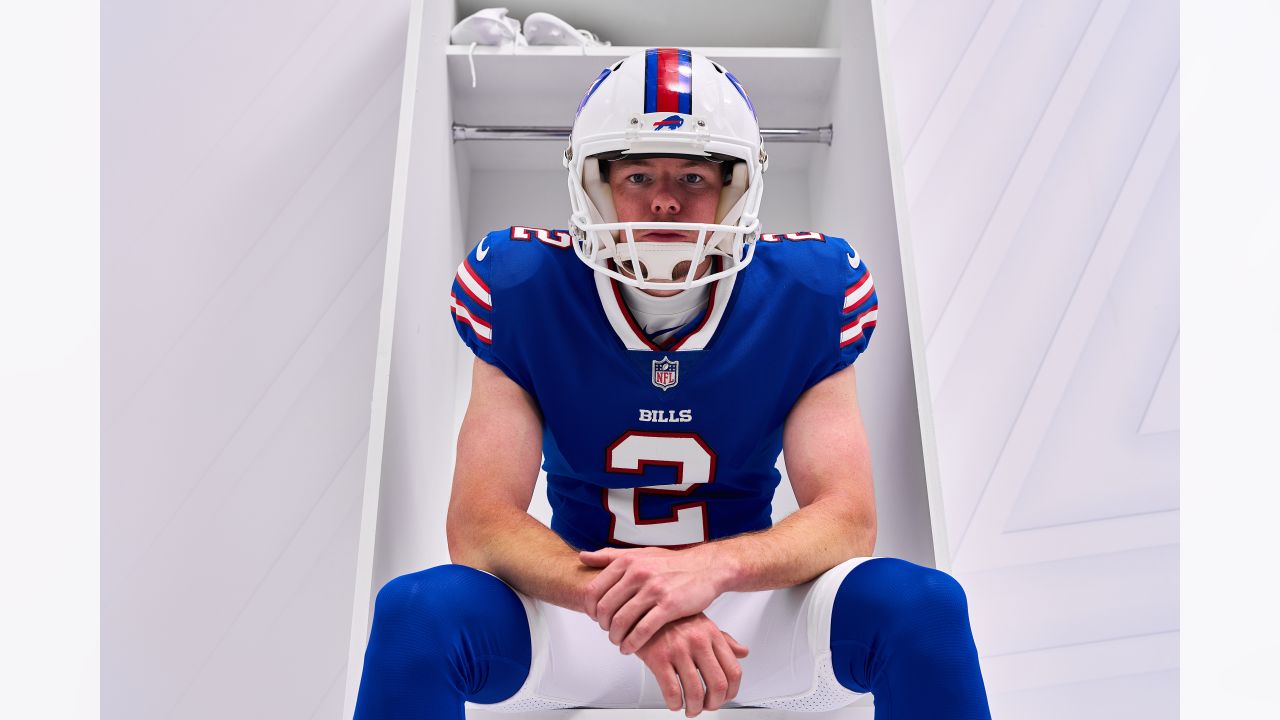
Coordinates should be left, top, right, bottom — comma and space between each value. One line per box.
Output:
579, 547, 722, 655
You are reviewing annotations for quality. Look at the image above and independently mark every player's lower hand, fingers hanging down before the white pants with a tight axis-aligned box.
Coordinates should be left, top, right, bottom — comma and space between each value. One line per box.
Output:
636, 612, 748, 717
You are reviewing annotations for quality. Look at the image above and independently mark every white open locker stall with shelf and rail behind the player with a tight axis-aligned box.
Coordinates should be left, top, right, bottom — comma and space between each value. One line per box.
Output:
346, 0, 947, 717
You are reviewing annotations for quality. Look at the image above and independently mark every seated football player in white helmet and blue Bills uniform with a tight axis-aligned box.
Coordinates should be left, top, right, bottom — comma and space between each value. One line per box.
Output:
356, 49, 989, 720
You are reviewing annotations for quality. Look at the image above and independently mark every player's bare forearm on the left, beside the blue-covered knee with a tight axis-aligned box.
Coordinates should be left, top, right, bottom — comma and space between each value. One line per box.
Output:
448, 506, 600, 612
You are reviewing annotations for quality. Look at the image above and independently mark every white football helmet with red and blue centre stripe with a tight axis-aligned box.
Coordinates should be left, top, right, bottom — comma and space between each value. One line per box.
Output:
564, 47, 768, 290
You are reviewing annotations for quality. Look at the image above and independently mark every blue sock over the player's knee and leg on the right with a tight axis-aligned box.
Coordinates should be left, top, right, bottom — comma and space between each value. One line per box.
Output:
831, 557, 991, 720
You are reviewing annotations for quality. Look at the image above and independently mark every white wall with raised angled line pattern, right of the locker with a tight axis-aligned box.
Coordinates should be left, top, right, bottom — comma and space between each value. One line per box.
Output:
884, 0, 1179, 719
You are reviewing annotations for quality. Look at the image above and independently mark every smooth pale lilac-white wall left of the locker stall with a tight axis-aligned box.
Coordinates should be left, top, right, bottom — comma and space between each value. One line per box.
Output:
101, 0, 408, 720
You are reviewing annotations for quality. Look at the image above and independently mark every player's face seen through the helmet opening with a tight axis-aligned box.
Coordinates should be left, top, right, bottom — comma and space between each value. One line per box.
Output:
609, 158, 724, 295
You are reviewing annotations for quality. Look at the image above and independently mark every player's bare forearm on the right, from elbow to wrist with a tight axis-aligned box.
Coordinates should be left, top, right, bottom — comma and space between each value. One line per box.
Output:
690, 498, 876, 592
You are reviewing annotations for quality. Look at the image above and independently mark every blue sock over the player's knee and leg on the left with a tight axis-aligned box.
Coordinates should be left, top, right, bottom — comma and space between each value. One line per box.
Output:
355, 565, 532, 720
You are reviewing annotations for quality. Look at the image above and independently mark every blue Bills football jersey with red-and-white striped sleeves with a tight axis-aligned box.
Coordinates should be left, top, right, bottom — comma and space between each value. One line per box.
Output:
449, 227, 878, 550
